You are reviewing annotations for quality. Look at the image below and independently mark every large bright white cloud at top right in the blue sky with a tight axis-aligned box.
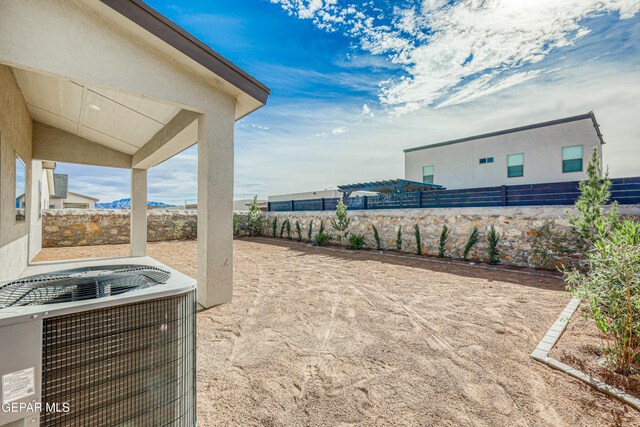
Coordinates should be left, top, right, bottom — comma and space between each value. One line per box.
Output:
270, 0, 640, 113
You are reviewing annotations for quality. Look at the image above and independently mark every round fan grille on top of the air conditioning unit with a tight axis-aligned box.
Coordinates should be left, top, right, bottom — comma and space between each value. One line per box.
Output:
0, 265, 171, 308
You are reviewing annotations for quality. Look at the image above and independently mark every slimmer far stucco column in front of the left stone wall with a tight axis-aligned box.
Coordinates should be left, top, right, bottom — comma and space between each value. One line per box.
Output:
130, 169, 147, 256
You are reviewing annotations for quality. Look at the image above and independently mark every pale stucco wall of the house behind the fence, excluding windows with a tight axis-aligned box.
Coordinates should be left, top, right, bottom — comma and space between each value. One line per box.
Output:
405, 119, 602, 189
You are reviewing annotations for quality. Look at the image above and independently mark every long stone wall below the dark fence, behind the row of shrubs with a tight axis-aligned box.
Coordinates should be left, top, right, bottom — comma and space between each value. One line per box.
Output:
262, 206, 640, 267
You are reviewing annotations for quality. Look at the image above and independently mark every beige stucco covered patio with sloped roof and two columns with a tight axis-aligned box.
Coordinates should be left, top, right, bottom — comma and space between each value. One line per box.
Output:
0, 0, 269, 307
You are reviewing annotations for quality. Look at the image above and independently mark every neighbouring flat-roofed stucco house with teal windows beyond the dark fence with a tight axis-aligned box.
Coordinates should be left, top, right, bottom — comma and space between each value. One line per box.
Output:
404, 112, 604, 189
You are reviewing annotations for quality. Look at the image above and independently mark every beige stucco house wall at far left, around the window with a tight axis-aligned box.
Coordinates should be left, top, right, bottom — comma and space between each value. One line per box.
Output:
0, 64, 32, 281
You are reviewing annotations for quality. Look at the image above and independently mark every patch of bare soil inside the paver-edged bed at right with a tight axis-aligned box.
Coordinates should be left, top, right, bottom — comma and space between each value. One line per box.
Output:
550, 307, 640, 398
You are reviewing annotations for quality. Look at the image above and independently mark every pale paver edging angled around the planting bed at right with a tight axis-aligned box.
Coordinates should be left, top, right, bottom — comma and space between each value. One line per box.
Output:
531, 297, 640, 411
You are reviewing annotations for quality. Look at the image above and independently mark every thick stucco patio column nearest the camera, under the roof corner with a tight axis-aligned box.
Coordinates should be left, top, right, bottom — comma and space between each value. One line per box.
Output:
198, 107, 234, 308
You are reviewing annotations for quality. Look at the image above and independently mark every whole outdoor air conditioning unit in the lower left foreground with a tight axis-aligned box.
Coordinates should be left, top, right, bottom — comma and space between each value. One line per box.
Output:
0, 265, 196, 427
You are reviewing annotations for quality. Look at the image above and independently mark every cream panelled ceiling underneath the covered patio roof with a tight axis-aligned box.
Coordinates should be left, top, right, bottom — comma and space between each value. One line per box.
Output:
14, 68, 180, 154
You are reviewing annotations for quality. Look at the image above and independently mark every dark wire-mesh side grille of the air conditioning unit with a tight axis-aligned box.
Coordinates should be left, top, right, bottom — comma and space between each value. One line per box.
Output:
41, 291, 195, 427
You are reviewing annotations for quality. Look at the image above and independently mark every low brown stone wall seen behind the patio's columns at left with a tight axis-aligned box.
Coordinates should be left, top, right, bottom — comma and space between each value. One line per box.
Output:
42, 209, 198, 248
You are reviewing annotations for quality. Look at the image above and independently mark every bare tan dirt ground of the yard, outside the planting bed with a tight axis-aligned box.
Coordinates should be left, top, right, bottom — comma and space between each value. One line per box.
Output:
33, 239, 640, 426
